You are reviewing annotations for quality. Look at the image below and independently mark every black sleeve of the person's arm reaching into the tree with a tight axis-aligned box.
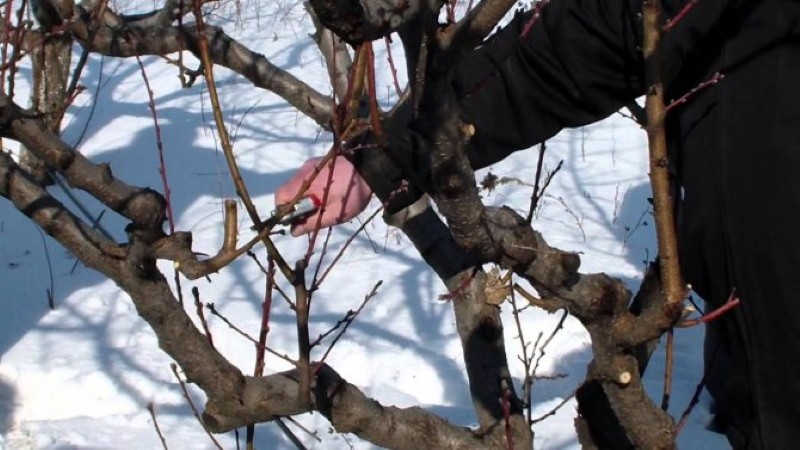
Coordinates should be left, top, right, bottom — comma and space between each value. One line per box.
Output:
452, 0, 745, 168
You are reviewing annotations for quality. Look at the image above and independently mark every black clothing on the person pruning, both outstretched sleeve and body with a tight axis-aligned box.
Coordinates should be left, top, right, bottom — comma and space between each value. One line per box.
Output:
356, 0, 800, 449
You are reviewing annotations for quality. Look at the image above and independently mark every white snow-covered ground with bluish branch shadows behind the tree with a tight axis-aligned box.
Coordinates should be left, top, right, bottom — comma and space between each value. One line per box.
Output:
0, 0, 727, 450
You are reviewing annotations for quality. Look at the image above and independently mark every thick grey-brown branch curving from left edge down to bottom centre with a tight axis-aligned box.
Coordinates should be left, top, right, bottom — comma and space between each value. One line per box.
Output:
0, 146, 504, 449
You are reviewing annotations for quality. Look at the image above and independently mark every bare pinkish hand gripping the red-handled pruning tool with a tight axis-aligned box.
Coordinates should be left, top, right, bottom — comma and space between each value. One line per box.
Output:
275, 156, 372, 236
